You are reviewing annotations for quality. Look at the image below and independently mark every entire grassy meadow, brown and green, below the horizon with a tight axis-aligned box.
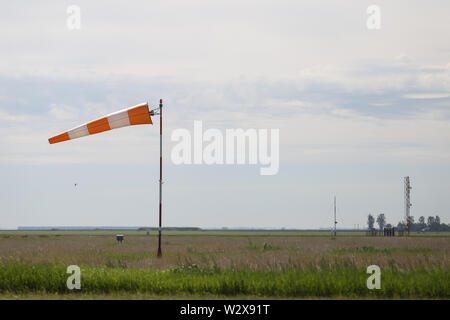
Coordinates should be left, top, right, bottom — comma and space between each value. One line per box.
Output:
0, 231, 450, 299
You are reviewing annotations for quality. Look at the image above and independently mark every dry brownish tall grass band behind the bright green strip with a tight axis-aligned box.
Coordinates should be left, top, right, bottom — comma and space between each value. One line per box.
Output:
0, 236, 450, 270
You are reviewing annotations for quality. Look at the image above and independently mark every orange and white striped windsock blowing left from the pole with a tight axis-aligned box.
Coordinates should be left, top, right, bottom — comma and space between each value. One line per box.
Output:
48, 103, 152, 144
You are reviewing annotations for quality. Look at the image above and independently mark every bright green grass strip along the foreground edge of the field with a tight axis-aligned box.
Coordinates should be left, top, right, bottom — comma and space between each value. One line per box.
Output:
0, 264, 450, 298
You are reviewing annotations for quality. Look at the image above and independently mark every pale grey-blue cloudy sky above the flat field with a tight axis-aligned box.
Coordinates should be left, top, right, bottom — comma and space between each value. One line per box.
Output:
0, 0, 450, 228
